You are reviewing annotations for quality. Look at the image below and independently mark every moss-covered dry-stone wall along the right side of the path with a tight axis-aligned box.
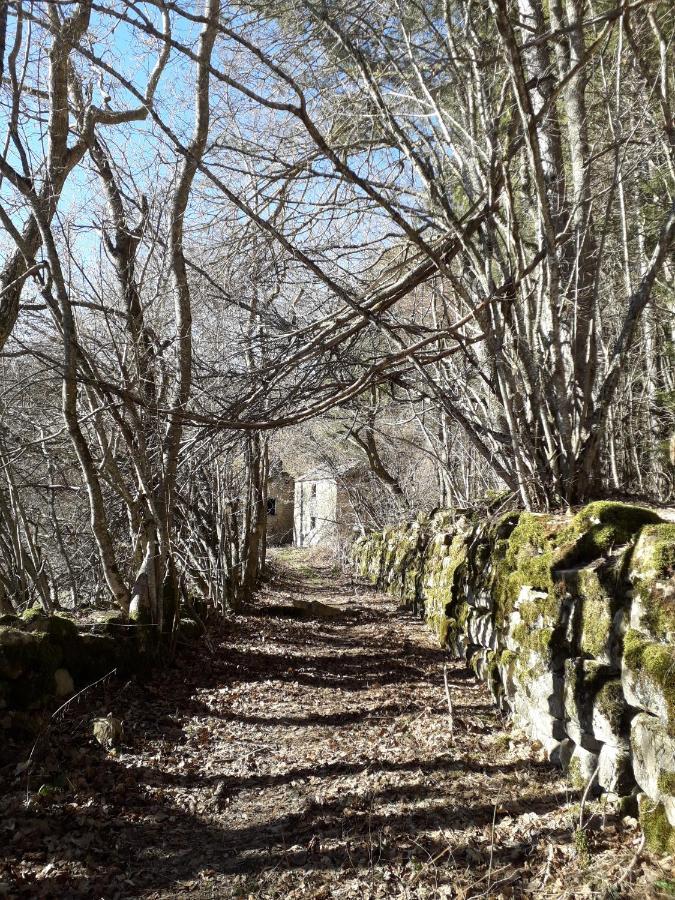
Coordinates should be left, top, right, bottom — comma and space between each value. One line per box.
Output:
352, 502, 675, 853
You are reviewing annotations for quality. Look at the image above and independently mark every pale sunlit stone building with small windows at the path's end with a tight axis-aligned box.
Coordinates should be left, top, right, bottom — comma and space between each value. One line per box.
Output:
293, 469, 358, 547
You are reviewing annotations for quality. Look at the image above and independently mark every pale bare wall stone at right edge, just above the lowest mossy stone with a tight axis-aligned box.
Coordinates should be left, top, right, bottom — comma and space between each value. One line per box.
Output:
630, 713, 675, 826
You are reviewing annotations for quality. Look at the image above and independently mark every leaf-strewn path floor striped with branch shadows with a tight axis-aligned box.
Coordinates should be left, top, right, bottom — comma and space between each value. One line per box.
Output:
0, 551, 674, 900
